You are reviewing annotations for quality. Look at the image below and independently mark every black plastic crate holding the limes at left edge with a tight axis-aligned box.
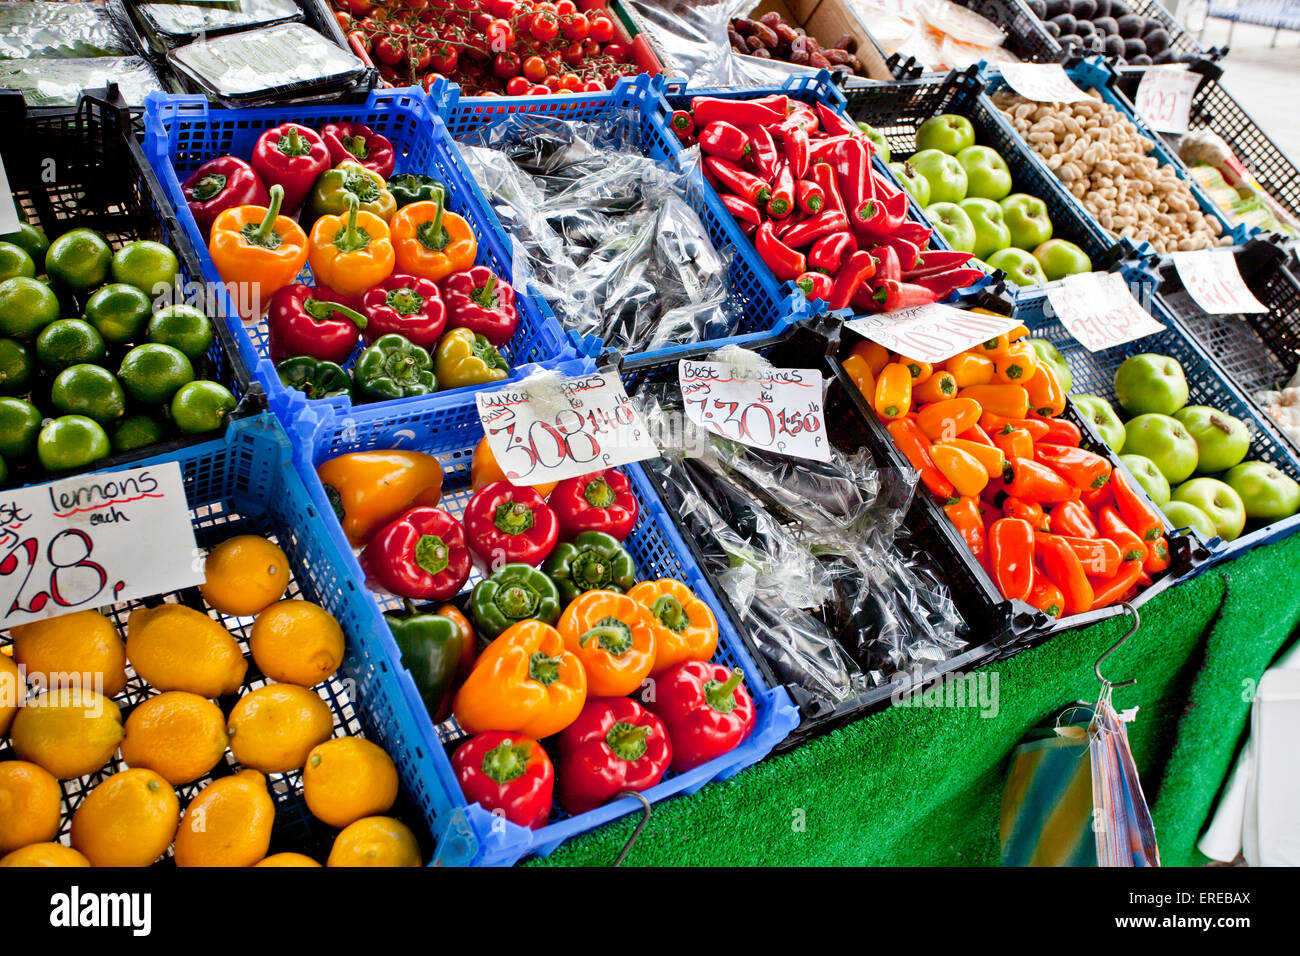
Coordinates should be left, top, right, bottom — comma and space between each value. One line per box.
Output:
0, 91, 267, 485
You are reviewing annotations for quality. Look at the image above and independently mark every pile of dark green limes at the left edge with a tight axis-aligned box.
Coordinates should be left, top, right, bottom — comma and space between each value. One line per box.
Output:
0, 224, 235, 484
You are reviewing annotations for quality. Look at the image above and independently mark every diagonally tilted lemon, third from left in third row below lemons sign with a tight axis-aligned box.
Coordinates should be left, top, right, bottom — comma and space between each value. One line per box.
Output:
176, 770, 276, 866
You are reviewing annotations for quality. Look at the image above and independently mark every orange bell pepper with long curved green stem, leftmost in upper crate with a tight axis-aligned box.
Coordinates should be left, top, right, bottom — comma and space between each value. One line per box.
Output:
208, 186, 307, 319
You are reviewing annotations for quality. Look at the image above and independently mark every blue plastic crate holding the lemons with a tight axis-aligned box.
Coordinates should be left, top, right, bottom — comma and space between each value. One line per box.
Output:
0, 412, 447, 862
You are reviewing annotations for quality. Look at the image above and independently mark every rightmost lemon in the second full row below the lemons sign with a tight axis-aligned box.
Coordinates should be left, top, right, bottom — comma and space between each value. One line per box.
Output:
226, 684, 334, 774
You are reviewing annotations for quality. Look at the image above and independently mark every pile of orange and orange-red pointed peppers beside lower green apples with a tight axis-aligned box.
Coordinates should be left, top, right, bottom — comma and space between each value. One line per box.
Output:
844, 325, 1170, 618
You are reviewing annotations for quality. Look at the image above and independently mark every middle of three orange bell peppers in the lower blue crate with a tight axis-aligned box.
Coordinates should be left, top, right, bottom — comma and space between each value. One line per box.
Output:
555, 591, 655, 697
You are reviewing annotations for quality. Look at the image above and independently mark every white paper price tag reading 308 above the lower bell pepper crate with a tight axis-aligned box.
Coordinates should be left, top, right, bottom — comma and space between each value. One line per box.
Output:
475, 372, 659, 485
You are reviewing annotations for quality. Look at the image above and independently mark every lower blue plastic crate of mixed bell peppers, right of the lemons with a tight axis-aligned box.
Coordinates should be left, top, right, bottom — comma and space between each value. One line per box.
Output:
298, 392, 798, 865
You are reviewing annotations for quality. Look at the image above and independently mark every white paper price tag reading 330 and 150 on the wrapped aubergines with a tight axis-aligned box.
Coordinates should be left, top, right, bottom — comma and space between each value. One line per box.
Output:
677, 359, 831, 462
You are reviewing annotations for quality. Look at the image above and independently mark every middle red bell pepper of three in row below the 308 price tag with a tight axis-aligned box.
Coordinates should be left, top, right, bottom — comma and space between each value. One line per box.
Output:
465, 481, 559, 567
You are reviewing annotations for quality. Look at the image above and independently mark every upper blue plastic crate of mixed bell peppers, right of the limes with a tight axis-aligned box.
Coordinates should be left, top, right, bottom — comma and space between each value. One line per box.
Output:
144, 88, 576, 423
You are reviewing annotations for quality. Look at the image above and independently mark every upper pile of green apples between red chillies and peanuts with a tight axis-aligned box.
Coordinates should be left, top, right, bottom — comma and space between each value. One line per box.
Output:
889, 113, 1092, 286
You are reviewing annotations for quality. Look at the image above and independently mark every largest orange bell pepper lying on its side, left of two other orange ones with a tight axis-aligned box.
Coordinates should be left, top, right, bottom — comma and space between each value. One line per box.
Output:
451, 620, 586, 740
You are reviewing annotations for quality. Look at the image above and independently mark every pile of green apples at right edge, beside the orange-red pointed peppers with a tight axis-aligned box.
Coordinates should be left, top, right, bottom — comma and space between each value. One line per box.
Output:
1071, 352, 1300, 541
